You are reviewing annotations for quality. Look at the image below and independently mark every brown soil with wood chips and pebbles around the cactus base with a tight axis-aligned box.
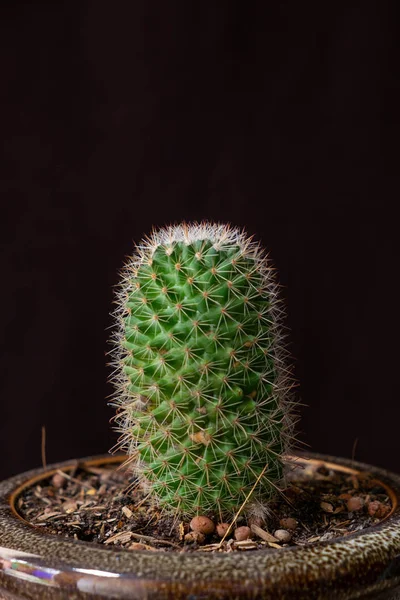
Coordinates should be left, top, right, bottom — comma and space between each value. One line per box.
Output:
16, 464, 391, 552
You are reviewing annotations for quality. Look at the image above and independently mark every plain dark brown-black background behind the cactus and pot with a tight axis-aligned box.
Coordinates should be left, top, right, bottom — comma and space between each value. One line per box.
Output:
0, 0, 400, 477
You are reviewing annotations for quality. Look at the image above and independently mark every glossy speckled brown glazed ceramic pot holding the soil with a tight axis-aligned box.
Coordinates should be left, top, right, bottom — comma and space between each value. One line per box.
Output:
0, 454, 400, 600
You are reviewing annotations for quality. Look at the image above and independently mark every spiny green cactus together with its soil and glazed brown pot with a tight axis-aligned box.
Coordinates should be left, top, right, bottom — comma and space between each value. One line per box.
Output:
0, 223, 400, 600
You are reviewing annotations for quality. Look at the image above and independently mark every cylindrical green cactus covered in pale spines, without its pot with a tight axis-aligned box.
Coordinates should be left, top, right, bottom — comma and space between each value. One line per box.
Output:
111, 223, 294, 516
